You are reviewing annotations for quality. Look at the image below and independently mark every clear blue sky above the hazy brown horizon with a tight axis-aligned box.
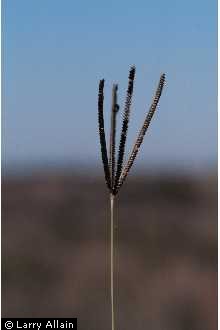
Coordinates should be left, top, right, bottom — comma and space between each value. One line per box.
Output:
2, 0, 217, 171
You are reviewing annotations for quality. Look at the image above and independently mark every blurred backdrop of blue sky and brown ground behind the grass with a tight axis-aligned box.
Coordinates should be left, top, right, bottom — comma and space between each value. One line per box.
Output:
2, 0, 217, 330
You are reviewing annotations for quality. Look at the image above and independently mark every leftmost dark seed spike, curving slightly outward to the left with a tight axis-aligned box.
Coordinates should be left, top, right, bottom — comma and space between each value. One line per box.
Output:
98, 79, 111, 192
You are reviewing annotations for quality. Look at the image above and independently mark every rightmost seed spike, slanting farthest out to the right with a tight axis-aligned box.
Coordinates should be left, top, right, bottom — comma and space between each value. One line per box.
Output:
115, 74, 165, 193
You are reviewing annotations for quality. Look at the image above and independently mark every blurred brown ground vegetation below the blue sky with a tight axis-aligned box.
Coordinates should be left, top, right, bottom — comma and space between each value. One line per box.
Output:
2, 174, 217, 330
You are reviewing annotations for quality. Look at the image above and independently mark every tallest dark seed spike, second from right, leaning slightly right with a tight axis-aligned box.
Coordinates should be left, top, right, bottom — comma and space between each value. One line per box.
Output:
113, 66, 135, 194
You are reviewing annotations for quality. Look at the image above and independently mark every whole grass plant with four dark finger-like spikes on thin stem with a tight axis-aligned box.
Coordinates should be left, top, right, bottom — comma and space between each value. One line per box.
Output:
98, 66, 165, 330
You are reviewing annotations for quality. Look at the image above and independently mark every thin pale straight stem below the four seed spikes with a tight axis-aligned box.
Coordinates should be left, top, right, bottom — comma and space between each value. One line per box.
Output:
110, 194, 115, 330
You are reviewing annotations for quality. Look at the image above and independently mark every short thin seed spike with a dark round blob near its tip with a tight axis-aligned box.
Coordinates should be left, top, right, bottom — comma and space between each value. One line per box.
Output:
109, 84, 119, 189
